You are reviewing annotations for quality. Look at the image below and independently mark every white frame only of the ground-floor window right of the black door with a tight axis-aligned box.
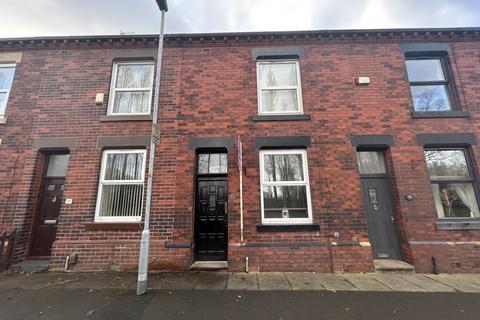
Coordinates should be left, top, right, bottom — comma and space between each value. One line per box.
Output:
259, 149, 312, 225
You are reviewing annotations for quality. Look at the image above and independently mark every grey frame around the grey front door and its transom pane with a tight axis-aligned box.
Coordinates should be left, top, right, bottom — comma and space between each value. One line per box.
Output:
356, 148, 404, 261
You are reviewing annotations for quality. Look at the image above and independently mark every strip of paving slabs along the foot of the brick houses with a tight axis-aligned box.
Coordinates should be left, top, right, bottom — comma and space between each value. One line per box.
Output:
0, 272, 480, 293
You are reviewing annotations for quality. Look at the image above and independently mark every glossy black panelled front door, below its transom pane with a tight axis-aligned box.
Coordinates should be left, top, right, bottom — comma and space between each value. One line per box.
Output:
195, 177, 228, 261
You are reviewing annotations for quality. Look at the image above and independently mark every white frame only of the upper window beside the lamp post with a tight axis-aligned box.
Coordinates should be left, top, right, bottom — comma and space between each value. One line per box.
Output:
107, 61, 155, 116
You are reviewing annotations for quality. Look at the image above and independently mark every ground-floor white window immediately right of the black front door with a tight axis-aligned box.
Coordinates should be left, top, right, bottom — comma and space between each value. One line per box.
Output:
260, 150, 312, 224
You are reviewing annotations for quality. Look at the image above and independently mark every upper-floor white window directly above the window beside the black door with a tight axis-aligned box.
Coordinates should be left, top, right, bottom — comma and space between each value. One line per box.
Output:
257, 60, 303, 115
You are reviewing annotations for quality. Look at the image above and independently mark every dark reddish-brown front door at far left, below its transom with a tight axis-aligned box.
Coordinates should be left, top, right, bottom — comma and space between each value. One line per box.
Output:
30, 178, 65, 256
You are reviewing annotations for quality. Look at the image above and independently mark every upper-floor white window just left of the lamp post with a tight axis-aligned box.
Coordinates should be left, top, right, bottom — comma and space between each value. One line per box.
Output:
108, 61, 154, 115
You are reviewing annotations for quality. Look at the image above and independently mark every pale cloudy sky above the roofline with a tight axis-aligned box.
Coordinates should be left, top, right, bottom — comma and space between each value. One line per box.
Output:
0, 0, 480, 37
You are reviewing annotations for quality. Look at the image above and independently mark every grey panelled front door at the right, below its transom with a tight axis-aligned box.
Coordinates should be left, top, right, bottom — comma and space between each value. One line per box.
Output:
361, 177, 402, 259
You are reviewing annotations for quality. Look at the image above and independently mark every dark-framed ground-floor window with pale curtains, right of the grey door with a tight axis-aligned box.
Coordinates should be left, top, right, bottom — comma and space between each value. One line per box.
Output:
425, 149, 480, 218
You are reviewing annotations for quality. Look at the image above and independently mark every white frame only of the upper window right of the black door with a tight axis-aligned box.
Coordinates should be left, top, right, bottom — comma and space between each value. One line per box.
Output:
257, 59, 303, 115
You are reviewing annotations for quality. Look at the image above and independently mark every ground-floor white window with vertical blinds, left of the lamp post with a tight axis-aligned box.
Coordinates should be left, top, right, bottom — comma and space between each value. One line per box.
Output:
95, 149, 147, 222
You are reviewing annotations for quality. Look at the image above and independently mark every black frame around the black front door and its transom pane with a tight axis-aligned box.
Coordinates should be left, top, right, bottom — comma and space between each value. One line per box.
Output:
192, 148, 229, 261
